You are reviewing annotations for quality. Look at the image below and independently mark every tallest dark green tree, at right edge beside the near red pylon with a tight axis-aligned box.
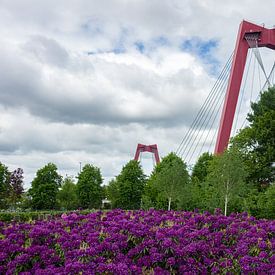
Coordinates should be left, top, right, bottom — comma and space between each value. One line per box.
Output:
231, 87, 275, 190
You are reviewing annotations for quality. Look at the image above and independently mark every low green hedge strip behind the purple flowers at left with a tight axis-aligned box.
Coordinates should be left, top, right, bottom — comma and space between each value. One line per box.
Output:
0, 210, 95, 222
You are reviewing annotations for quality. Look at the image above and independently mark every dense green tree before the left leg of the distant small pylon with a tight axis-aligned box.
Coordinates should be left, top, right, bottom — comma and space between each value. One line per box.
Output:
114, 160, 146, 209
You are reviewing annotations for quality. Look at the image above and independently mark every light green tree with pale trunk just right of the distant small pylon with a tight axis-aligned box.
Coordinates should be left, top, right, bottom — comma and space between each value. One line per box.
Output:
143, 153, 189, 210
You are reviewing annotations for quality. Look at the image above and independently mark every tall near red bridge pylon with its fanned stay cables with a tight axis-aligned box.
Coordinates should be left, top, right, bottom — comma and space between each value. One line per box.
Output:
176, 21, 275, 164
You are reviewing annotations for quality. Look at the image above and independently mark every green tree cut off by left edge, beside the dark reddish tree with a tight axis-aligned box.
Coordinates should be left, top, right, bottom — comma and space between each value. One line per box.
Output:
0, 162, 11, 209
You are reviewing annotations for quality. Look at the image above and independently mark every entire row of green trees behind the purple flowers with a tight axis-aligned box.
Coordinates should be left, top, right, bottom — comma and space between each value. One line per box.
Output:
0, 87, 275, 219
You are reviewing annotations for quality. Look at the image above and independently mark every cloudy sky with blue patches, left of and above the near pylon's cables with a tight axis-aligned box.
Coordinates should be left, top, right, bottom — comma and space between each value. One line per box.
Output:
0, 0, 275, 187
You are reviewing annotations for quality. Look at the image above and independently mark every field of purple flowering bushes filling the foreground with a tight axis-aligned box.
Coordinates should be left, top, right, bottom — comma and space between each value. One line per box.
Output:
0, 210, 275, 275
